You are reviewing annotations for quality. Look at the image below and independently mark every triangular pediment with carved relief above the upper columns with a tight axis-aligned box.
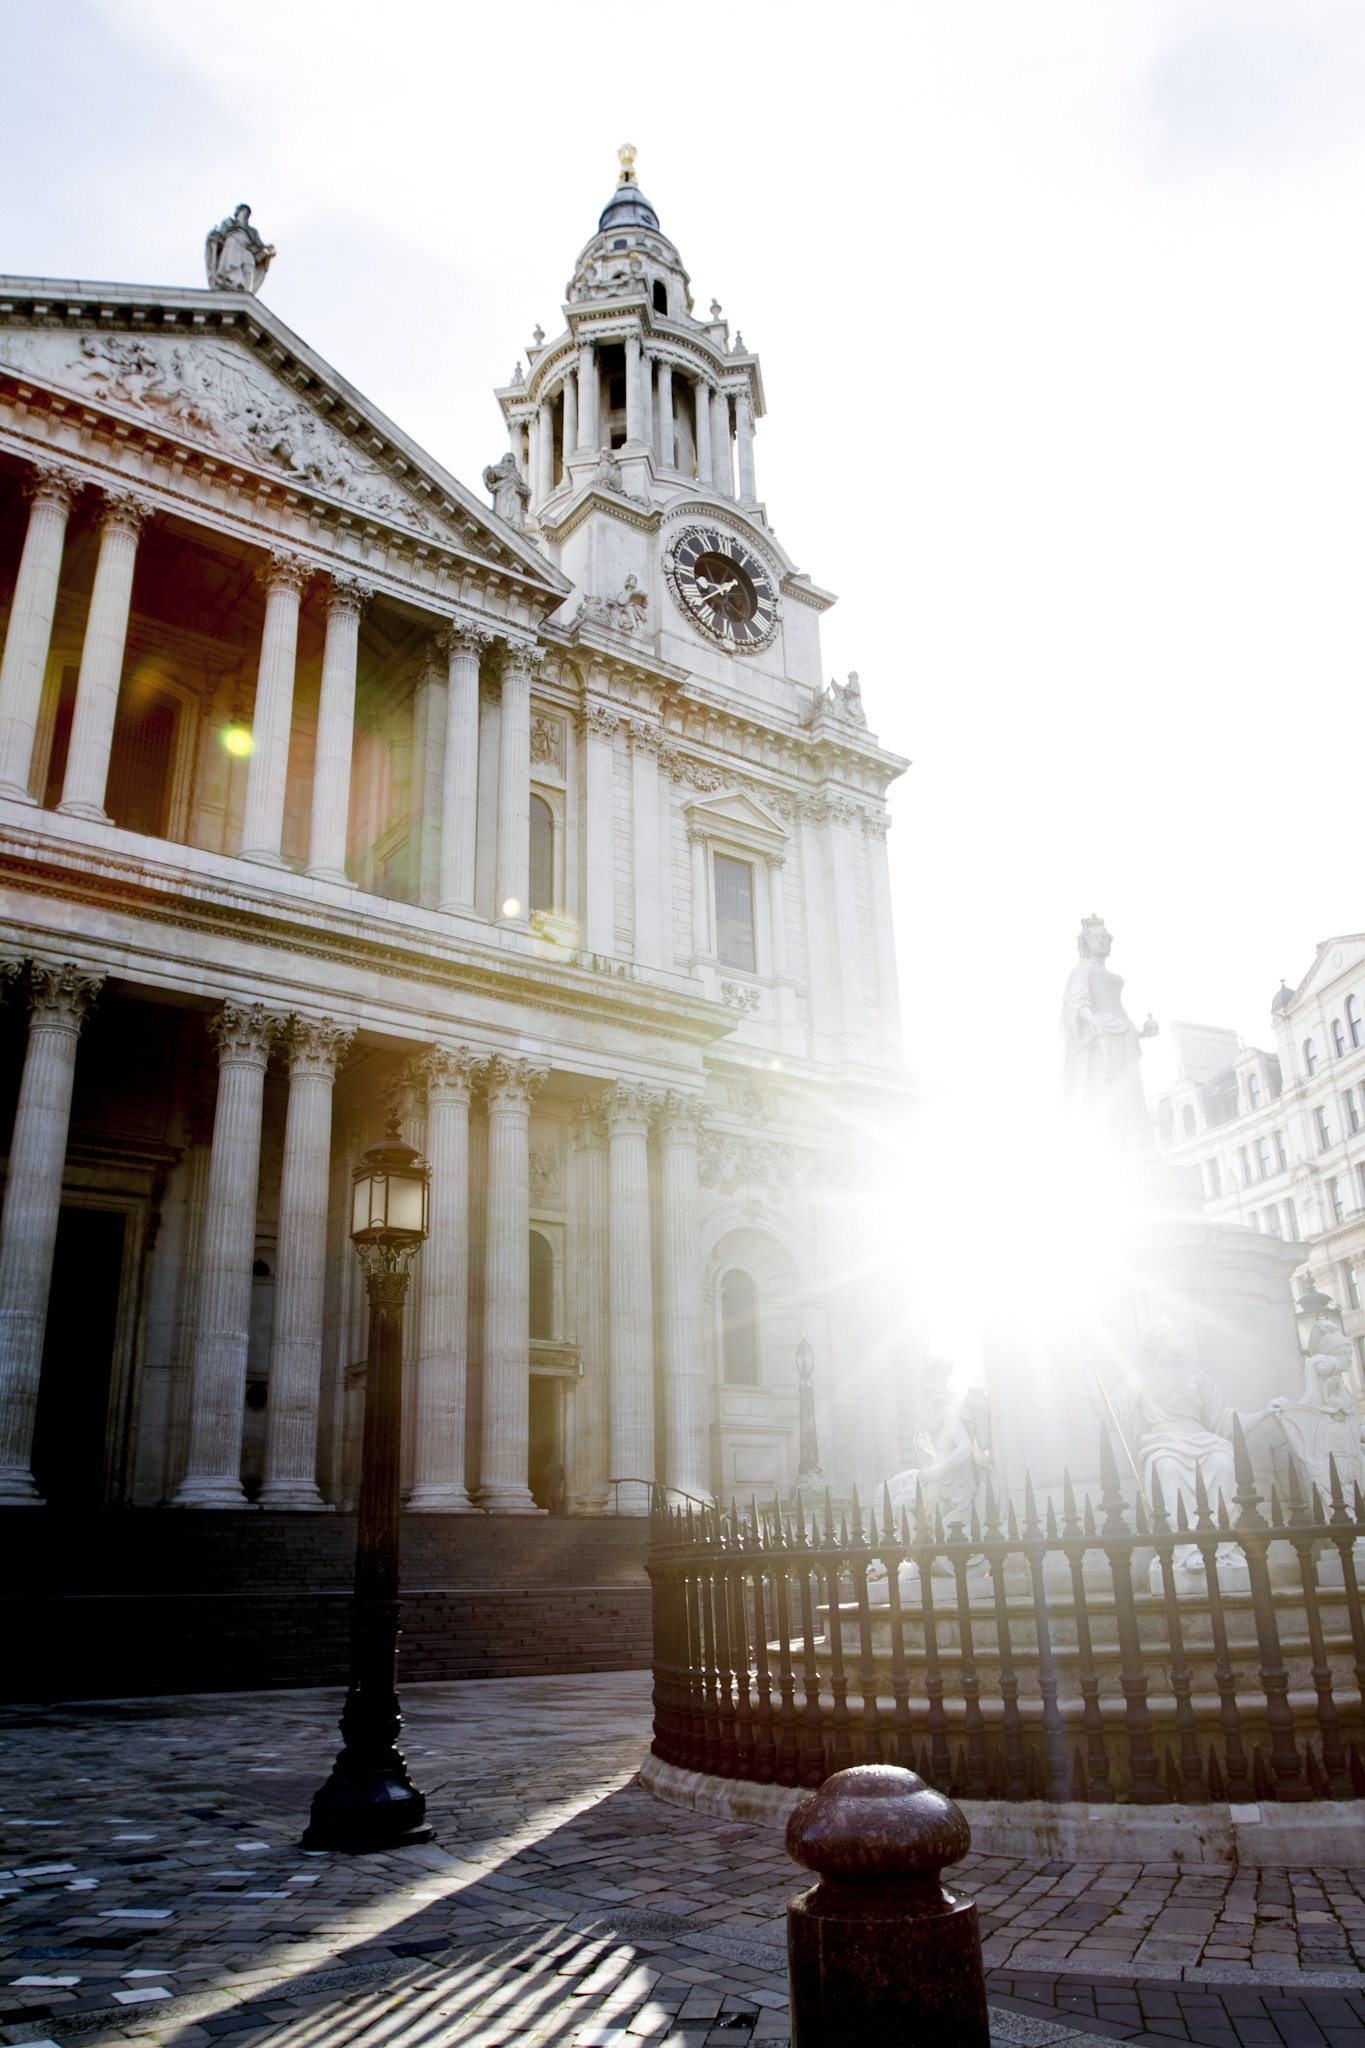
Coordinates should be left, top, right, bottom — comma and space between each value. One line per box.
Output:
0, 276, 569, 625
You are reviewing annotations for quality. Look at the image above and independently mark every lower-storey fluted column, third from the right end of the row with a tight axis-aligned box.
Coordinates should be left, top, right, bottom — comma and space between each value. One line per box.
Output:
479, 1055, 546, 1516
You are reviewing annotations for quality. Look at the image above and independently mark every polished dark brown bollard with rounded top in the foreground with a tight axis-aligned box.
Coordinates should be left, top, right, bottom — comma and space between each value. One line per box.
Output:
786, 1763, 990, 2048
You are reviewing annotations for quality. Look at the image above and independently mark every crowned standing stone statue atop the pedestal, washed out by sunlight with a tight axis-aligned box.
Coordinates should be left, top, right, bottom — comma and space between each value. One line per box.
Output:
1062, 918, 1158, 1155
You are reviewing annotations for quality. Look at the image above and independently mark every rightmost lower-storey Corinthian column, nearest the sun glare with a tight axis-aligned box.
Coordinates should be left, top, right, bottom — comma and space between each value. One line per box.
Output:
659, 1090, 712, 1501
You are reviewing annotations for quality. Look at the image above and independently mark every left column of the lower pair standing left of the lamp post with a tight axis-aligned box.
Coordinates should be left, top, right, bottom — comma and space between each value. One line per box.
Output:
176, 1004, 282, 1507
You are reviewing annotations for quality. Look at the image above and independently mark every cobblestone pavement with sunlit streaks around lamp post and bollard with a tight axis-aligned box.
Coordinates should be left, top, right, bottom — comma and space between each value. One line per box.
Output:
0, 1673, 1365, 2048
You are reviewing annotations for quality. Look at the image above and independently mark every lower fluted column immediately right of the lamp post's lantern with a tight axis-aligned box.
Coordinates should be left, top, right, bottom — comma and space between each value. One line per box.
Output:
407, 1044, 479, 1516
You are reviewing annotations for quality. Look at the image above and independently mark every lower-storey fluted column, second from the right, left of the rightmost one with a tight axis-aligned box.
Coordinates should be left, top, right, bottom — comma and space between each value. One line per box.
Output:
602, 1081, 657, 1516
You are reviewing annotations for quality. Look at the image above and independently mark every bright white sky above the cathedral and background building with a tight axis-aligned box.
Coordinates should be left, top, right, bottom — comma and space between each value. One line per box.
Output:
0, 0, 1365, 1359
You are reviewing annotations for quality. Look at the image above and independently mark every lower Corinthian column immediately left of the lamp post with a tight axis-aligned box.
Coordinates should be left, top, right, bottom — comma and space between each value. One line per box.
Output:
260, 1018, 354, 1509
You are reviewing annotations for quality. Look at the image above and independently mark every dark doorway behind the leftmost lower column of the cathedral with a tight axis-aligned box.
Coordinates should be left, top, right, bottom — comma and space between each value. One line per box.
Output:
33, 1208, 127, 1507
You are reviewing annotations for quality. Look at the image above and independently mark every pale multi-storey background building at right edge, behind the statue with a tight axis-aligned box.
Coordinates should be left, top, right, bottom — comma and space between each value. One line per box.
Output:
1156, 932, 1365, 1395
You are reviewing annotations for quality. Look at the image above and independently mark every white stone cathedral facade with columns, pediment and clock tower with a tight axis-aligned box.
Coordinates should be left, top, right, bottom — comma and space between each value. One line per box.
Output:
0, 152, 909, 1513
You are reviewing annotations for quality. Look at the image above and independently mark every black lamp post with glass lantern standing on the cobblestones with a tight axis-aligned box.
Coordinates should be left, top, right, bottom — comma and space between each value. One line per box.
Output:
303, 1118, 432, 1851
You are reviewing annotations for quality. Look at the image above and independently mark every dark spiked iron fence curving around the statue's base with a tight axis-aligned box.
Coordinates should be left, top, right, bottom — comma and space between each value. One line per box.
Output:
649, 1427, 1365, 1806
